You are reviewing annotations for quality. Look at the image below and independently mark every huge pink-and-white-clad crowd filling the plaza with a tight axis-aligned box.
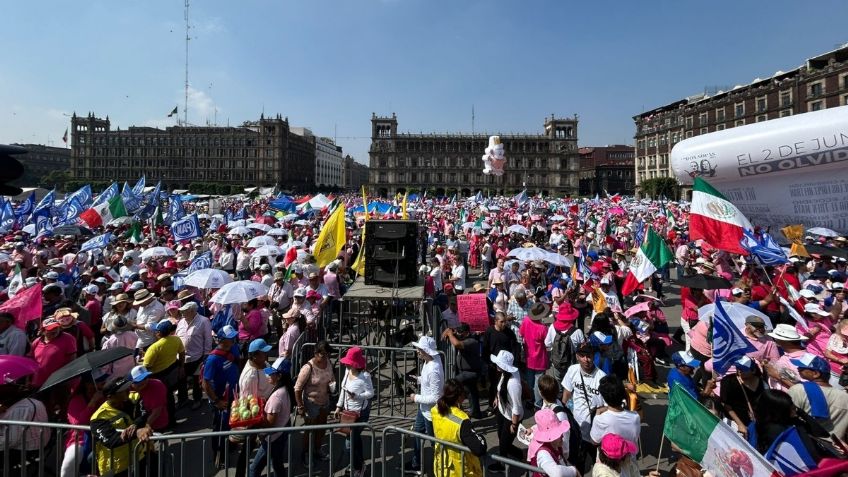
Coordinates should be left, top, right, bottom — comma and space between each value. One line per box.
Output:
0, 190, 848, 477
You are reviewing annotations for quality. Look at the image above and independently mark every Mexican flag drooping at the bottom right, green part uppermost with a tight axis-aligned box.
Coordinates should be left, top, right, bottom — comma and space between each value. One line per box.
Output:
663, 384, 781, 477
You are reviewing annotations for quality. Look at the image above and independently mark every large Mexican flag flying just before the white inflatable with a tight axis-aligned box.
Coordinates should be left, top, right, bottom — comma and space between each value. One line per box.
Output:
689, 177, 754, 255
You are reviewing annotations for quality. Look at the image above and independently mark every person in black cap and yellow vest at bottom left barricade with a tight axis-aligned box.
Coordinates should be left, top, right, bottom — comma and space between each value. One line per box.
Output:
91, 376, 156, 477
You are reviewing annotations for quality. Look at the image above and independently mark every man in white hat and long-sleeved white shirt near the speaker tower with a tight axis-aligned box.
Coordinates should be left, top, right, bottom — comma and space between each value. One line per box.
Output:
406, 336, 445, 471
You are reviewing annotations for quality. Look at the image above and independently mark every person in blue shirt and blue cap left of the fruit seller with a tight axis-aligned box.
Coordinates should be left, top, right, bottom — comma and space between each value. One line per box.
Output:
201, 325, 239, 468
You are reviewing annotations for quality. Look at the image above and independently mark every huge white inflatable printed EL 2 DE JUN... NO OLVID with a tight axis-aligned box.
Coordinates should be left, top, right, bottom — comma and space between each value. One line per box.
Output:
671, 106, 848, 234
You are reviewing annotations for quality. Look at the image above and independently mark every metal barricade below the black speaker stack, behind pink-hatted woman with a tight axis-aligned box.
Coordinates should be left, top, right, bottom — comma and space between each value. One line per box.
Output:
292, 343, 428, 419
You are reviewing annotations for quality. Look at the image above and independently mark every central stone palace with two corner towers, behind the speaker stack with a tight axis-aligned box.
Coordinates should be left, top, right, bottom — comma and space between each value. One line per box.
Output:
368, 113, 580, 197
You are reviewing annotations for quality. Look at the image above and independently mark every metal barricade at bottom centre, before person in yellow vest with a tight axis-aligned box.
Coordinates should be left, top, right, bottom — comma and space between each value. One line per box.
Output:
380, 426, 548, 477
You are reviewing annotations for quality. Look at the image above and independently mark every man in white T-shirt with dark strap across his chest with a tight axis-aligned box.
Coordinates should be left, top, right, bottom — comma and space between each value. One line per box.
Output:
562, 343, 606, 446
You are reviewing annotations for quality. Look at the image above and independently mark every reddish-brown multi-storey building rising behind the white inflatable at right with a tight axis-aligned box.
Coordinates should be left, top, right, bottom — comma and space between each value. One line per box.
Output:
633, 45, 848, 198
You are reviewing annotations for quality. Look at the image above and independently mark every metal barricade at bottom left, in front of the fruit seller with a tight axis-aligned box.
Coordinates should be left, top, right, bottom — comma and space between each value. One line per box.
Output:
131, 422, 376, 477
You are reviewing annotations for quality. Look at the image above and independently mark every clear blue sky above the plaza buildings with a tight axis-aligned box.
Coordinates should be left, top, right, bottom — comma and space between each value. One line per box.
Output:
0, 0, 848, 163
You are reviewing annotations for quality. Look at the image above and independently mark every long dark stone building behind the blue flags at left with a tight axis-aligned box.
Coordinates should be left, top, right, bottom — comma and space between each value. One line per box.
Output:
70, 114, 315, 192
